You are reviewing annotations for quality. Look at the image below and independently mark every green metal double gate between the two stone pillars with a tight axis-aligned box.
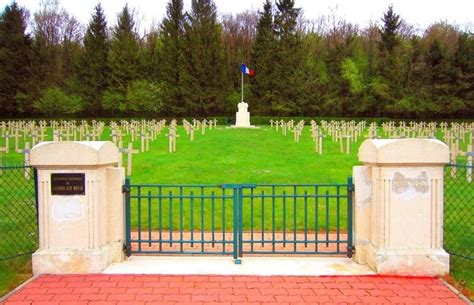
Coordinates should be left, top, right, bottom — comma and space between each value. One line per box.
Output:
123, 178, 353, 261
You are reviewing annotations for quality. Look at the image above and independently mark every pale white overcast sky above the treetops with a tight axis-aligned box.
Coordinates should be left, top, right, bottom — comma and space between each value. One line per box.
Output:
0, 0, 474, 30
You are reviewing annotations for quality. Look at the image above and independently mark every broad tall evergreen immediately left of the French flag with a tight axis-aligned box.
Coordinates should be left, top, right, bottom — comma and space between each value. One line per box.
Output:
183, 0, 228, 116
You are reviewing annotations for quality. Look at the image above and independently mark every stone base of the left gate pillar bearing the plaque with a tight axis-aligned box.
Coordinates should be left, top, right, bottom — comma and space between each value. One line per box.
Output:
32, 242, 124, 275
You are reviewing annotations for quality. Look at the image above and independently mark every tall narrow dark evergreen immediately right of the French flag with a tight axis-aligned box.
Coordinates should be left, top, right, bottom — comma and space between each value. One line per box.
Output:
251, 0, 276, 113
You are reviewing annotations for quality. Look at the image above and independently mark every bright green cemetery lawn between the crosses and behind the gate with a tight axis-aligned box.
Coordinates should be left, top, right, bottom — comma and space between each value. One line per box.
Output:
0, 122, 474, 296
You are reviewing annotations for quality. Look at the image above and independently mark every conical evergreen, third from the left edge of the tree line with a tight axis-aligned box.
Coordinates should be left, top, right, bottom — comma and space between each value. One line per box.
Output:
109, 5, 140, 96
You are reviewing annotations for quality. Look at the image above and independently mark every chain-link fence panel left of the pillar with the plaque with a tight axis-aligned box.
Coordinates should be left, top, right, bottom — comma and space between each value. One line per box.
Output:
0, 165, 38, 260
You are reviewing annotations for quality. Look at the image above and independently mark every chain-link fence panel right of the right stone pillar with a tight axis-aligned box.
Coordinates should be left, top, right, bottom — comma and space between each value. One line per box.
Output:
444, 164, 474, 287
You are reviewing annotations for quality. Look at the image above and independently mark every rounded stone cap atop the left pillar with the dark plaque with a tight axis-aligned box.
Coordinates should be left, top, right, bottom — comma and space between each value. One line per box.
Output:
30, 141, 120, 167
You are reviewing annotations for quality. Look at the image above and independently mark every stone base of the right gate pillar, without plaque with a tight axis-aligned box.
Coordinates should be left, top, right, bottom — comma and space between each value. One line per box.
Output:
367, 247, 449, 276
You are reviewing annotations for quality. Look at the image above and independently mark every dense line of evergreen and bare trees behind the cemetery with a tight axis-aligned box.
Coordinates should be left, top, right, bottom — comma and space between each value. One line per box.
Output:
0, 0, 474, 119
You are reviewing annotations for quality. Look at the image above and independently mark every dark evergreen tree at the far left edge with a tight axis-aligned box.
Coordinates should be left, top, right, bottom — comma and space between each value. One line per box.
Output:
0, 2, 31, 115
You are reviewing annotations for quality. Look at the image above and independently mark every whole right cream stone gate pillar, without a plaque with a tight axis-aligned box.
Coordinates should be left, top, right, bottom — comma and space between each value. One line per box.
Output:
353, 139, 449, 275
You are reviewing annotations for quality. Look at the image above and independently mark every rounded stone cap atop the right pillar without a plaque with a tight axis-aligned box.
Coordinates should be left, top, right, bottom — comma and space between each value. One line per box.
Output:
359, 139, 449, 165
